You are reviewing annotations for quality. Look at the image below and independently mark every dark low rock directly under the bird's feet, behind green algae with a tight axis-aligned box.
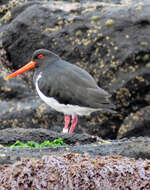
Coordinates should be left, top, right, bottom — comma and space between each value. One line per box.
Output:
0, 128, 97, 146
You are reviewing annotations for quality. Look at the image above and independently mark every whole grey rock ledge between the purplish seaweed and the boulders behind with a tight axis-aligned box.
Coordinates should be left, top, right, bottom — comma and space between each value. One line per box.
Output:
0, 128, 150, 164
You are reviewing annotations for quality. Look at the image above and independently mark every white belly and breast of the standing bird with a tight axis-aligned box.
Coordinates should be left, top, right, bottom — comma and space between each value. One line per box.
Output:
35, 74, 101, 116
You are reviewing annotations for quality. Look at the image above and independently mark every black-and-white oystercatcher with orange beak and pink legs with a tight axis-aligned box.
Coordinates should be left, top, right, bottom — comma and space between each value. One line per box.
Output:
8, 49, 115, 133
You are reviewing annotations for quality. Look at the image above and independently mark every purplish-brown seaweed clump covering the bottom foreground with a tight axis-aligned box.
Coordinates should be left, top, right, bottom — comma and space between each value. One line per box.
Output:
0, 154, 150, 190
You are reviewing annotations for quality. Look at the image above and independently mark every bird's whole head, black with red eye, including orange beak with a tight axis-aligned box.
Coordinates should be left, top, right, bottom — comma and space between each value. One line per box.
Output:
7, 49, 59, 79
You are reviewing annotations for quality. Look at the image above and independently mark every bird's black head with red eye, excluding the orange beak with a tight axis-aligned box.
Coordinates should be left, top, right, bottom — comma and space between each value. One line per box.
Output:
32, 49, 59, 67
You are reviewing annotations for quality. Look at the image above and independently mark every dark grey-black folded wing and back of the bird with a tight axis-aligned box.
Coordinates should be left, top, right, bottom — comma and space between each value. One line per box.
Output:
38, 60, 114, 111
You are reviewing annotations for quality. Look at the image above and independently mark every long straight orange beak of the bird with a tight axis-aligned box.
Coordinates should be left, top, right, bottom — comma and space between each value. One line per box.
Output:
7, 61, 36, 79
